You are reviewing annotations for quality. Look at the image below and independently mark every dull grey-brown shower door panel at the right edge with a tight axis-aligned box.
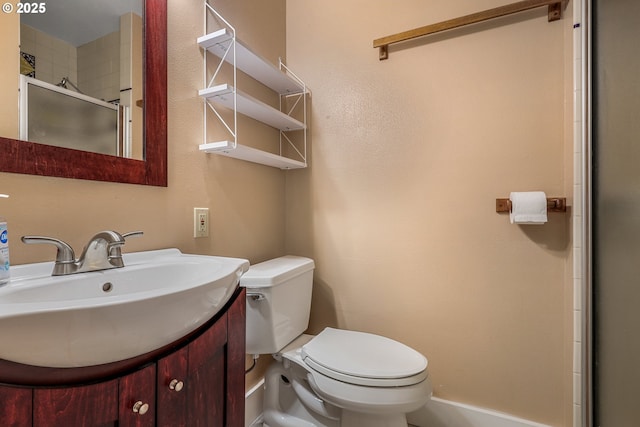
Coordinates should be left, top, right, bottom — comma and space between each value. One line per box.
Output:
592, 0, 640, 427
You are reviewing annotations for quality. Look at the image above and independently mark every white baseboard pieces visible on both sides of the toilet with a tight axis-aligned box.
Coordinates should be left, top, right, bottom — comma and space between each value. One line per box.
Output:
245, 378, 550, 427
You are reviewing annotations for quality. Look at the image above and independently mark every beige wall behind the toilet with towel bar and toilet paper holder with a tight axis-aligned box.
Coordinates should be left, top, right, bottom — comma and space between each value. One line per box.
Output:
286, 0, 572, 426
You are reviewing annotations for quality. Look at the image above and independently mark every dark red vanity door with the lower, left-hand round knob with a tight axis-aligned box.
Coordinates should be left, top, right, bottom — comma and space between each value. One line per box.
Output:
118, 364, 156, 427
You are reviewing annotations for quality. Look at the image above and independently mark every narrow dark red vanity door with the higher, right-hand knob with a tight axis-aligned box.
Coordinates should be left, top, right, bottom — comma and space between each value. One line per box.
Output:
156, 347, 189, 427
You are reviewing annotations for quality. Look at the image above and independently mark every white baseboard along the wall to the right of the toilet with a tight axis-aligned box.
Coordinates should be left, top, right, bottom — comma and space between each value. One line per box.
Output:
407, 397, 550, 427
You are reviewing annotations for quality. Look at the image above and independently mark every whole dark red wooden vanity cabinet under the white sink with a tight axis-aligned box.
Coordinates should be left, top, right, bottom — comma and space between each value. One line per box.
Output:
0, 289, 245, 427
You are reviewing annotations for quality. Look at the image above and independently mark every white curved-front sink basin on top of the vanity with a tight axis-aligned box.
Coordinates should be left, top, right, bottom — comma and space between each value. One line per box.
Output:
0, 249, 249, 368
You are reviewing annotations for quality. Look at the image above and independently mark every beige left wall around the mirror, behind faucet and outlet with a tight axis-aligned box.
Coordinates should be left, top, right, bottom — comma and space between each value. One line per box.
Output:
0, 0, 285, 270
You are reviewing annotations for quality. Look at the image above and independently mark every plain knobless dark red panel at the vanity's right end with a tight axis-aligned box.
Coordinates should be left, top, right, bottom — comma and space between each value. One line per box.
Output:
187, 314, 228, 427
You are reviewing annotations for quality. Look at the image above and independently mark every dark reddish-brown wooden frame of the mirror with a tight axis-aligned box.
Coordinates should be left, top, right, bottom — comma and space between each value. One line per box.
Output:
0, 0, 167, 187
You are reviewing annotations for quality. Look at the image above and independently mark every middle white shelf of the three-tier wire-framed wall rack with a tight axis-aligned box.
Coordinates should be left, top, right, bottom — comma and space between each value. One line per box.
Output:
198, 83, 305, 131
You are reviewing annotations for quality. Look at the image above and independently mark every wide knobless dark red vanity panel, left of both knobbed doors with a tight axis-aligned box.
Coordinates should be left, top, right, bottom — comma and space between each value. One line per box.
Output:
33, 380, 118, 427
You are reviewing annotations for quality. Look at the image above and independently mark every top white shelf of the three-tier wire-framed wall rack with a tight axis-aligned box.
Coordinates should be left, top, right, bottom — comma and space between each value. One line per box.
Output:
198, 28, 305, 94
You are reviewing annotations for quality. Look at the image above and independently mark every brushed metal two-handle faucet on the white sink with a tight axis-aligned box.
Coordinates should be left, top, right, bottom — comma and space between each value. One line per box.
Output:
21, 231, 142, 276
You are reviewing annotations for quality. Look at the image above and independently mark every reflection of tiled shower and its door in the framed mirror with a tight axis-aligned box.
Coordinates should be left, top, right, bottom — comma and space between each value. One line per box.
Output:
19, 0, 144, 159
